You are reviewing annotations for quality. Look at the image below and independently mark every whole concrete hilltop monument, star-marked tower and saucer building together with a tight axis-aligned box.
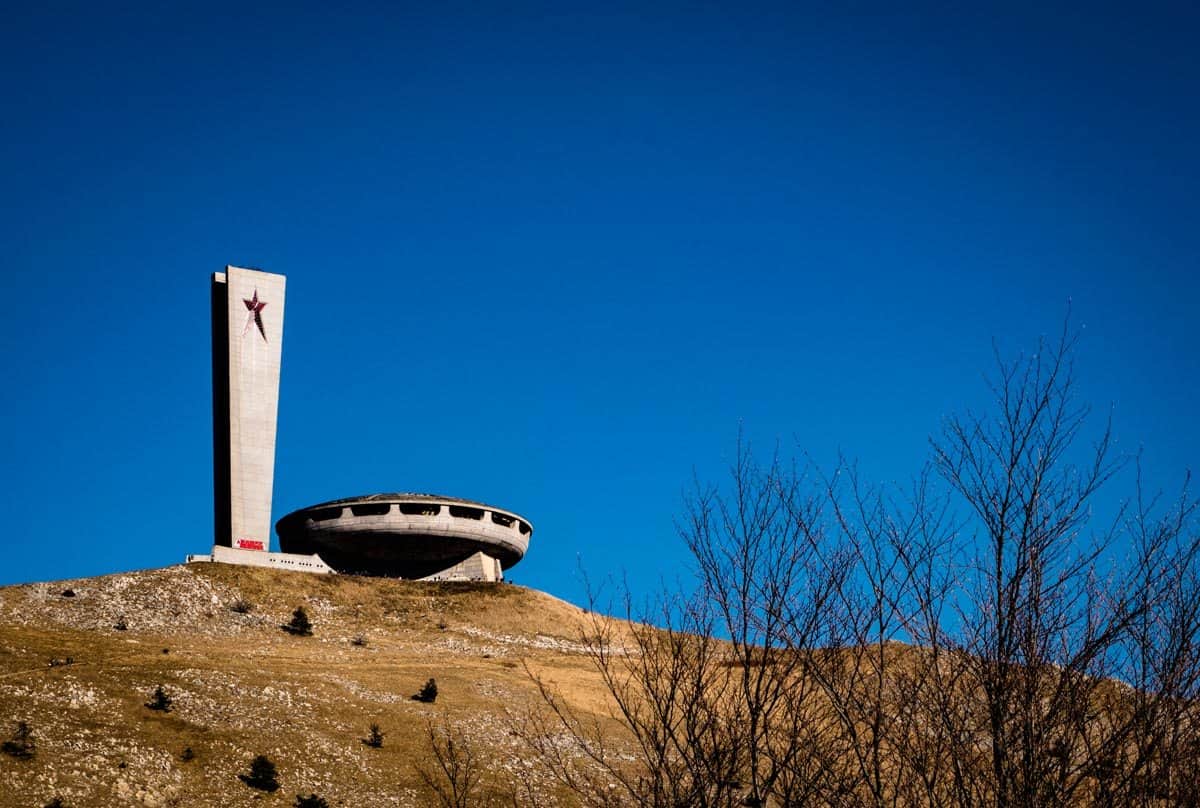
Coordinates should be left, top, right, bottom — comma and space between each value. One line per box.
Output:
187, 267, 533, 581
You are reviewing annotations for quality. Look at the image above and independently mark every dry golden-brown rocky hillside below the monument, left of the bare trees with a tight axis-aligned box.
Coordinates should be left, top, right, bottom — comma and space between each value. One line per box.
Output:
0, 564, 602, 808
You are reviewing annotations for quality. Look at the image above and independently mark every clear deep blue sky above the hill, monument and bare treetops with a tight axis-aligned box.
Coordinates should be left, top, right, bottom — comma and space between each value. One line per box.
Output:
0, 2, 1200, 599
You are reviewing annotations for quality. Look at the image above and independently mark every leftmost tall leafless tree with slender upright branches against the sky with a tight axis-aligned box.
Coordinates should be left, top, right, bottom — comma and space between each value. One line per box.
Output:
679, 436, 853, 807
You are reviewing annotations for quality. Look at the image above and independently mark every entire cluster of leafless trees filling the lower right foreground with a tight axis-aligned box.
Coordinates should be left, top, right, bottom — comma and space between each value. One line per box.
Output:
521, 324, 1200, 808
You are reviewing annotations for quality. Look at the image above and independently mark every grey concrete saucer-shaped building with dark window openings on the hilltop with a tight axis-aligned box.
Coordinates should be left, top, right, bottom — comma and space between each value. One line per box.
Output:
275, 493, 533, 579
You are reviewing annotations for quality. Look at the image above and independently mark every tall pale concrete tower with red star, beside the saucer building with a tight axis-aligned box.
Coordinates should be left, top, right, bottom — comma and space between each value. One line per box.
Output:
211, 267, 287, 550
